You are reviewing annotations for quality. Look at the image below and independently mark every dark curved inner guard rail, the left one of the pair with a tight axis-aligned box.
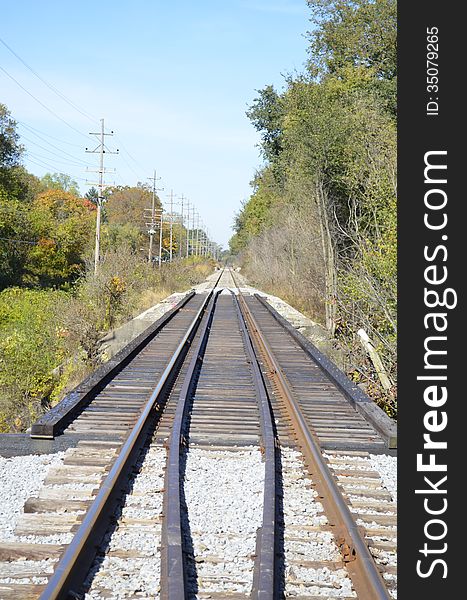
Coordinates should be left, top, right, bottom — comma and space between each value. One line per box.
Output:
161, 290, 220, 600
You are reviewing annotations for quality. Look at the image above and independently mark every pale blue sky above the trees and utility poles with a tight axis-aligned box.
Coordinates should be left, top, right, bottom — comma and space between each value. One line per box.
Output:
0, 0, 310, 247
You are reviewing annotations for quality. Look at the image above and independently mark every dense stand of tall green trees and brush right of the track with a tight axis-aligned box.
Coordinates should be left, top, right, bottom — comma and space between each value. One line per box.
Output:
230, 0, 397, 414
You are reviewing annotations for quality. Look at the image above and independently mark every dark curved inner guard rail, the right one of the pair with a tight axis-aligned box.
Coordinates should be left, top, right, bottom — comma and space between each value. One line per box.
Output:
231, 290, 277, 600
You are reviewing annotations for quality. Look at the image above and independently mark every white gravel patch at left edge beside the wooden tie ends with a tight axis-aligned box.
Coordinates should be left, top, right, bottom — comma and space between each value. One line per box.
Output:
0, 452, 65, 542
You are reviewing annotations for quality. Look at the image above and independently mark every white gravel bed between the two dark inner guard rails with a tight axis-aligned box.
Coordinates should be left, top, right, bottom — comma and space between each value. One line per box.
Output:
184, 447, 264, 594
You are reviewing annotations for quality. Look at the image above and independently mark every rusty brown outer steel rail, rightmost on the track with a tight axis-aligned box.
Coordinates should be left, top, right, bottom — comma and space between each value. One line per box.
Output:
234, 286, 391, 600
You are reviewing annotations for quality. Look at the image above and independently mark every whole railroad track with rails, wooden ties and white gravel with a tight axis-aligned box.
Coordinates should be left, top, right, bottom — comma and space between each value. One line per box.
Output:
0, 270, 396, 600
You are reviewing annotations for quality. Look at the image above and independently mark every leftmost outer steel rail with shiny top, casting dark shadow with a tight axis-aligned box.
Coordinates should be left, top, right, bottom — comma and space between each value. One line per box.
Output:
40, 284, 222, 600
